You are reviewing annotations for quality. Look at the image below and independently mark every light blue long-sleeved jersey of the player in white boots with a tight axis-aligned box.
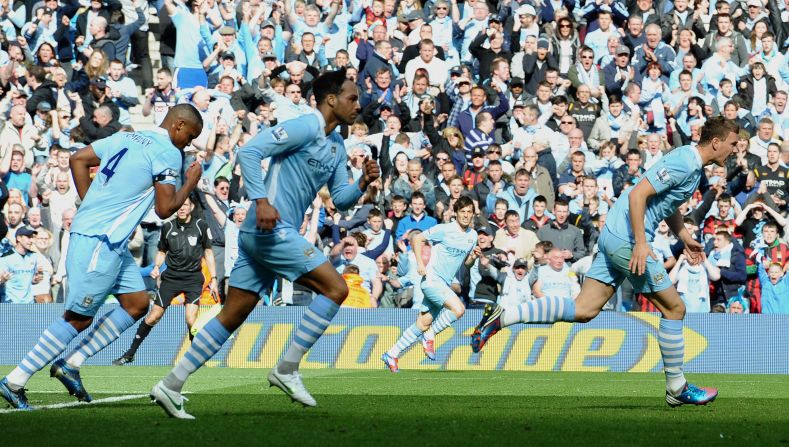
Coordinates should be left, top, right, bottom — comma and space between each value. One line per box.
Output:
238, 111, 362, 233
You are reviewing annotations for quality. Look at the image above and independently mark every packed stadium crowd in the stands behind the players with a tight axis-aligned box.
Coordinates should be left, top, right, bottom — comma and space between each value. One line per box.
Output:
0, 0, 789, 313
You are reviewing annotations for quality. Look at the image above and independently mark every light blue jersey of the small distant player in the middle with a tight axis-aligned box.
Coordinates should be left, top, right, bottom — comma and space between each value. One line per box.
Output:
422, 222, 477, 285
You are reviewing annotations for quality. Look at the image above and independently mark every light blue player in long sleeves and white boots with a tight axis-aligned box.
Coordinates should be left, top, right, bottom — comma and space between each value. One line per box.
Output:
151, 69, 380, 419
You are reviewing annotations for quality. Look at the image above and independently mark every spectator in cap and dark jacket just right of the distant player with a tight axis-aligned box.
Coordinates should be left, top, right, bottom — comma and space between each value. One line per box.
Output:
468, 224, 507, 308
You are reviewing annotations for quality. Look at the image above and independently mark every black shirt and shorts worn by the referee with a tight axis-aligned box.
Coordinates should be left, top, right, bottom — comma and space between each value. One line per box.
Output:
154, 217, 211, 309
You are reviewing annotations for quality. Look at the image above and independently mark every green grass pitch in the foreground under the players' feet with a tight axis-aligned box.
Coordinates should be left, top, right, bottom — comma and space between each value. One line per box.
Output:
0, 366, 789, 447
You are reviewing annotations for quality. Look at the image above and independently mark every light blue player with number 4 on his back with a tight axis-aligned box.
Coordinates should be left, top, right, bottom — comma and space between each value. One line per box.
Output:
0, 104, 203, 409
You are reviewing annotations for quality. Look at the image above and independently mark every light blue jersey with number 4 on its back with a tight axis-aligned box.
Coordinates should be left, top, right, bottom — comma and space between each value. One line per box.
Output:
71, 128, 183, 245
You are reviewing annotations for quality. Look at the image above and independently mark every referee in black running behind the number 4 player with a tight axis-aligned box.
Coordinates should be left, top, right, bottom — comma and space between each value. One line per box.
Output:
112, 199, 219, 366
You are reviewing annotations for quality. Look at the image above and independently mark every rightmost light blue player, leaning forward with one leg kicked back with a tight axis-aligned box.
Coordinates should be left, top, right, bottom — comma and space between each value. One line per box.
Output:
471, 117, 739, 407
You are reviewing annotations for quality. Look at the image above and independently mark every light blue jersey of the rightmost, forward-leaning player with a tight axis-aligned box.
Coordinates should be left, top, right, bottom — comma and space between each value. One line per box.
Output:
605, 146, 703, 242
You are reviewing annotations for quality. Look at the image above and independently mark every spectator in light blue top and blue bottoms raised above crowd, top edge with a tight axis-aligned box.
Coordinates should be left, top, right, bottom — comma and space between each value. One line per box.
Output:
164, 0, 208, 89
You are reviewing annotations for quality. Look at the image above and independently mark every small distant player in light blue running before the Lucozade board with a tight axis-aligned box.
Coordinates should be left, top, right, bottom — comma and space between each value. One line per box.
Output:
381, 197, 481, 373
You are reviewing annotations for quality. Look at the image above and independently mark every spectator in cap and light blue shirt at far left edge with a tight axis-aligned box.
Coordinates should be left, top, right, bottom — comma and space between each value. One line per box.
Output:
0, 227, 47, 304
